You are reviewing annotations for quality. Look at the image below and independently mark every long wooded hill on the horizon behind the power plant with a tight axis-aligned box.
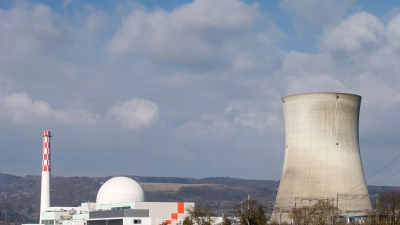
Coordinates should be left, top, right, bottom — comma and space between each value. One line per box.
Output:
0, 173, 392, 224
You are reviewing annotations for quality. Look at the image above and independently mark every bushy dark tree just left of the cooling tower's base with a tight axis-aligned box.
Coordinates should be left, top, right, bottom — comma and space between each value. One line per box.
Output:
232, 199, 267, 225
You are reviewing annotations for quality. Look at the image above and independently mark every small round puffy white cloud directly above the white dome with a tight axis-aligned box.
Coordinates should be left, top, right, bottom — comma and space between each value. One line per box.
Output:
110, 98, 158, 130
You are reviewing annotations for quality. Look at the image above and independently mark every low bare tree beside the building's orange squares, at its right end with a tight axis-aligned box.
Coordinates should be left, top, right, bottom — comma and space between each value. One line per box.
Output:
185, 206, 215, 225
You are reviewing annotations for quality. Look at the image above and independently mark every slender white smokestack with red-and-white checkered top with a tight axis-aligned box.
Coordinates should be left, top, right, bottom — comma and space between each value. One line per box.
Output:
39, 130, 51, 224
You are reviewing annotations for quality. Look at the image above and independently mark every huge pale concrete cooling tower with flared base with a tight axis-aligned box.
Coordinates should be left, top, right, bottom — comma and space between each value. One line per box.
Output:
271, 93, 372, 222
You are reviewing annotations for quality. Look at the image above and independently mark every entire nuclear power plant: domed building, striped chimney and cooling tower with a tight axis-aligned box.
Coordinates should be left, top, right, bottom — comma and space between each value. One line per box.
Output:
26, 93, 372, 225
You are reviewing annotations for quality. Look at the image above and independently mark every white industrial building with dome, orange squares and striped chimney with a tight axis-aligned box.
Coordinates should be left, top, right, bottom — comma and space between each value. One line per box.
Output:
30, 130, 194, 225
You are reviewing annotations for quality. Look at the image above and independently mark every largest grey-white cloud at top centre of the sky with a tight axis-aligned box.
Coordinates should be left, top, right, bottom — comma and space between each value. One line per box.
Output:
108, 0, 259, 67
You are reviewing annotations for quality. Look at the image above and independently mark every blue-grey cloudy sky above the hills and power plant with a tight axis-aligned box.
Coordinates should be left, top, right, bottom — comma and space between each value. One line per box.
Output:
0, 0, 400, 186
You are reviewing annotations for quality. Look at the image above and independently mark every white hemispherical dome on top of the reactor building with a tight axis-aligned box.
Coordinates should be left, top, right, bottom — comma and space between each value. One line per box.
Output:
96, 177, 144, 205
